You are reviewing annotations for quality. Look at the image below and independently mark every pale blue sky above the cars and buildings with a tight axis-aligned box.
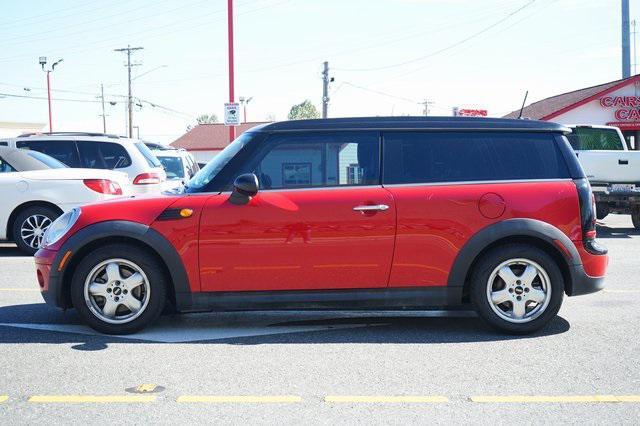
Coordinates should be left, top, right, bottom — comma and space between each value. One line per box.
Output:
0, 0, 640, 142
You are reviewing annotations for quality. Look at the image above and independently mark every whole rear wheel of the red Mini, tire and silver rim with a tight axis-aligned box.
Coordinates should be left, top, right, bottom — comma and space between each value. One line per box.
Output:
471, 244, 564, 334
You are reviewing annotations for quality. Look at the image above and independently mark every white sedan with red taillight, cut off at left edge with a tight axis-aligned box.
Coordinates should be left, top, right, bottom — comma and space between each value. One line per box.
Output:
0, 146, 131, 254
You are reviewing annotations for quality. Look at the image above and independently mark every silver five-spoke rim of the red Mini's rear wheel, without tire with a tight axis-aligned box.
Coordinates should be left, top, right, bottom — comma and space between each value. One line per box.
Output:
487, 259, 551, 323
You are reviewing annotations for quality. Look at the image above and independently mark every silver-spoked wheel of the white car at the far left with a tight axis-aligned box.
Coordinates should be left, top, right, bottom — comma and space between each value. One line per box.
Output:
12, 206, 60, 255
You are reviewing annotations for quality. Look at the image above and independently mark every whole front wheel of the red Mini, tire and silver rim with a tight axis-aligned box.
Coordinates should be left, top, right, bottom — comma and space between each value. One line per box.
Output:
71, 244, 167, 334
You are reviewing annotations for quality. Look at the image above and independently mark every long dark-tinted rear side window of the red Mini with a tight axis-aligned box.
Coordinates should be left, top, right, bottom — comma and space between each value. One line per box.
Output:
383, 132, 570, 184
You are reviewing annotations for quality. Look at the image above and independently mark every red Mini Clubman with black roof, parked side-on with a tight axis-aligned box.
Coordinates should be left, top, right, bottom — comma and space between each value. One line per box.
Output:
35, 117, 608, 334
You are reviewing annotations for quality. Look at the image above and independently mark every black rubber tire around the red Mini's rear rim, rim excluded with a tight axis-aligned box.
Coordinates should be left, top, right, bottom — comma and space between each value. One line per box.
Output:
470, 244, 564, 334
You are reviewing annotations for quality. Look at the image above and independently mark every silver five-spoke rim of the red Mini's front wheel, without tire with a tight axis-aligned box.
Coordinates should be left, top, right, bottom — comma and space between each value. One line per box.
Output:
84, 259, 151, 324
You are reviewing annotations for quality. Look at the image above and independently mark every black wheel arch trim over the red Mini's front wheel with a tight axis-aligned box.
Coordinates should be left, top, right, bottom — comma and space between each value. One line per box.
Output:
45, 220, 191, 308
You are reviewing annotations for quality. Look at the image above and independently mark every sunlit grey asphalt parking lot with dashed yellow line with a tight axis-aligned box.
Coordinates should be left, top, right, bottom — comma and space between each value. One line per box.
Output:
0, 215, 640, 424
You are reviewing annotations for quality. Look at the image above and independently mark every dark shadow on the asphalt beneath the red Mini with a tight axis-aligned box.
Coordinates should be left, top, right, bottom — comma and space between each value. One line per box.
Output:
0, 303, 570, 351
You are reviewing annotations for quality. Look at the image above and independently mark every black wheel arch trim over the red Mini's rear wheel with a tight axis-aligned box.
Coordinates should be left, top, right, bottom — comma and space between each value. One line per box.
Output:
447, 218, 585, 295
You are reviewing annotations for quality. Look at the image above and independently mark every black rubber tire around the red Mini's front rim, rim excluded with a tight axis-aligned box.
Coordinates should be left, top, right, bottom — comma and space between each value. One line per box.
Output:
71, 244, 168, 334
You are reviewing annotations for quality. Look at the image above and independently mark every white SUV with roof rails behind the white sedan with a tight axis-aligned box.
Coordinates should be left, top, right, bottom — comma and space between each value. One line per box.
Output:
0, 132, 167, 194
